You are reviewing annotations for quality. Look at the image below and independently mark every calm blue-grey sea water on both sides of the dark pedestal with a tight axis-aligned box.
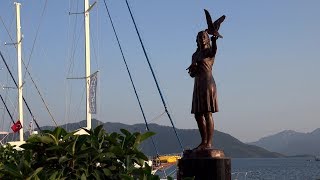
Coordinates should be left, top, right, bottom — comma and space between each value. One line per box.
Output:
157, 158, 320, 180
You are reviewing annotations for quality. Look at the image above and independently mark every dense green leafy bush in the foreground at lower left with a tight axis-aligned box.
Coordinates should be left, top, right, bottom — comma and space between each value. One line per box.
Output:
0, 126, 159, 180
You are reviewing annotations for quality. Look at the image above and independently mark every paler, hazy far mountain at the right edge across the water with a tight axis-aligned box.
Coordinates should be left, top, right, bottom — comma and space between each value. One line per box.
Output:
249, 128, 320, 156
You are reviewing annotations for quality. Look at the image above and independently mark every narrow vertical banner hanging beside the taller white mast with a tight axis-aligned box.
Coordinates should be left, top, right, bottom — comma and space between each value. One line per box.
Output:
89, 71, 98, 114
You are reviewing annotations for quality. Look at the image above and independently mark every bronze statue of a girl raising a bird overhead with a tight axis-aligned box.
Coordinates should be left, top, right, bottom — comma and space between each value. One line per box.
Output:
188, 10, 225, 150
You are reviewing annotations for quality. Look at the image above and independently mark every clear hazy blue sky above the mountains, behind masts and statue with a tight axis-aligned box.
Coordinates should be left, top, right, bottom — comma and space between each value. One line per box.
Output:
0, 0, 320, 142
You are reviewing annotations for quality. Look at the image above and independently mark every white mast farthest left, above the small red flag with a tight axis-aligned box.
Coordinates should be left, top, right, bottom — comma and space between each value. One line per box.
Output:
15, 2, 23, 141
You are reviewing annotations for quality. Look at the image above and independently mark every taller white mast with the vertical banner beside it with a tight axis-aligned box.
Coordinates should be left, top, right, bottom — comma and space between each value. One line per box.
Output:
84, 0, 91, 129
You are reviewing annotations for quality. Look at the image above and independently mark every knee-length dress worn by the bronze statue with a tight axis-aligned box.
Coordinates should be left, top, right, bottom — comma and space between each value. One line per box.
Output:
191, 49, 219, 114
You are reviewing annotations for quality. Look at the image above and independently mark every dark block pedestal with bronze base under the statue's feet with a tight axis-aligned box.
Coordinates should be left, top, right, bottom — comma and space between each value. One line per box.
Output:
177, 149, 231, 180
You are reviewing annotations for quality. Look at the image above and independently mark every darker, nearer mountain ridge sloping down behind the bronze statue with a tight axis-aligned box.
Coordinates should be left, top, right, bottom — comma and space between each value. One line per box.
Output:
2, 120, 282, 158
